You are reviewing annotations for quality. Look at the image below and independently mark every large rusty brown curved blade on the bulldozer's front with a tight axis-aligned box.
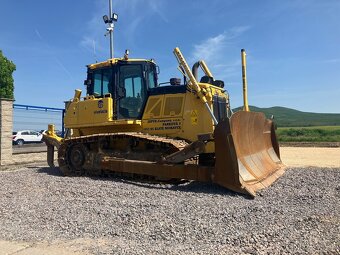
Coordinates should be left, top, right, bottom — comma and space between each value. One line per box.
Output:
213, 111, 285, 196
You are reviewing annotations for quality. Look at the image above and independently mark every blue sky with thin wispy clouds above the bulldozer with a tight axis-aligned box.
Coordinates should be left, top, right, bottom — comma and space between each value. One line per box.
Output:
0, 0, 340, 113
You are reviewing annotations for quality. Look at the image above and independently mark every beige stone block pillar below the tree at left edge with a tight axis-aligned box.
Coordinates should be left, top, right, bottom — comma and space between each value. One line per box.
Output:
0, 98, 14, 165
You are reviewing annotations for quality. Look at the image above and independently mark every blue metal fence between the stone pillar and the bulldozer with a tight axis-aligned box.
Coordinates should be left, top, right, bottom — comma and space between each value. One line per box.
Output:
13, 104, 65, 135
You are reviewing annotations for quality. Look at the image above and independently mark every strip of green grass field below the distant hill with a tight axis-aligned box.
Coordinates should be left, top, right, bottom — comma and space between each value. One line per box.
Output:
276, 126, 340, 142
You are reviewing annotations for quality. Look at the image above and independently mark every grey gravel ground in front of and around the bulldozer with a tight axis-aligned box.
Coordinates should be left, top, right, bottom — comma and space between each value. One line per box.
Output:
0, 166, 340, 254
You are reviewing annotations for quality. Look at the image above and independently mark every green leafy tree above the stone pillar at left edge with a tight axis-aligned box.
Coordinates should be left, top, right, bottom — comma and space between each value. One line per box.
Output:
0, 50, 16, 99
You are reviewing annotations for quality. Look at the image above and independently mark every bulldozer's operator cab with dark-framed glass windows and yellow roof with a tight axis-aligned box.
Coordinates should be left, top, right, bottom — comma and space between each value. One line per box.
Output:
85, 59, 157, 119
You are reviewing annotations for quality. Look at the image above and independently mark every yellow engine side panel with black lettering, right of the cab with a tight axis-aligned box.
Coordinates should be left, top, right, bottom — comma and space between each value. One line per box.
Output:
142, 92, 213, 152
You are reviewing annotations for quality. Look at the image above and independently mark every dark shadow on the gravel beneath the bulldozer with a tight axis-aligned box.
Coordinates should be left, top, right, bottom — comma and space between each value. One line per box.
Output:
35, 167, 252, 199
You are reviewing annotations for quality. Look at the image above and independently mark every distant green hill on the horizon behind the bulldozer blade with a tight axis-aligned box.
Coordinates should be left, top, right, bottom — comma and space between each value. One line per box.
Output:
233, 106, 340, 127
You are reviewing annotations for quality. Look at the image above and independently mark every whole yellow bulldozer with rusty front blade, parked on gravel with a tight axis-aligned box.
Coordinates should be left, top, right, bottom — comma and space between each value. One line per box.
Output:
43, 45, 285, 196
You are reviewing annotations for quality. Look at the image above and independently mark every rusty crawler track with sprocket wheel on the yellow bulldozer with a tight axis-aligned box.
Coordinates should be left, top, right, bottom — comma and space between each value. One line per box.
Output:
58, 132, 188, 179
